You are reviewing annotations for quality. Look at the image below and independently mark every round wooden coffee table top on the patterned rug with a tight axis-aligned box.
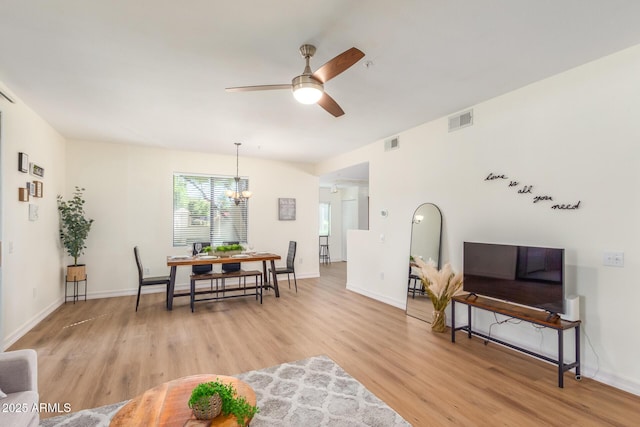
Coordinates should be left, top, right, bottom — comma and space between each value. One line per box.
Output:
109, 375, 256, 427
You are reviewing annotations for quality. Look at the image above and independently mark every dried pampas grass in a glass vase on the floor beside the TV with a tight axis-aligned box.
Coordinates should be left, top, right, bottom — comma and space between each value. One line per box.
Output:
411, 256, 462, 332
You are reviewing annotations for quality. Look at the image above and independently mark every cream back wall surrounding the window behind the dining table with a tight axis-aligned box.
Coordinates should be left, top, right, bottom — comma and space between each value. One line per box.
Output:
66, 141, 319, 300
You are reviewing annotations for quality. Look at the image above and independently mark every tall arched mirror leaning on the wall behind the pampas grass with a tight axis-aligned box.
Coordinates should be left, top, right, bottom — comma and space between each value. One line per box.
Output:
407, 203, 442, 322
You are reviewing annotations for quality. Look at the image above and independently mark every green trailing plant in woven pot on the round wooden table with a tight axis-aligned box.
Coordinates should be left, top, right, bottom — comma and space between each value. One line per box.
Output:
189, 379, 258, 427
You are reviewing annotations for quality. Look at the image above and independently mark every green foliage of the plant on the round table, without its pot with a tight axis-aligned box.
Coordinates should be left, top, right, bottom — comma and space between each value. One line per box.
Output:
189, 378, 259, 427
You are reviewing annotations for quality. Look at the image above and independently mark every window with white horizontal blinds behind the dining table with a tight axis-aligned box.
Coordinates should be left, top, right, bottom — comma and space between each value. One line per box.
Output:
173, 173, 249, 246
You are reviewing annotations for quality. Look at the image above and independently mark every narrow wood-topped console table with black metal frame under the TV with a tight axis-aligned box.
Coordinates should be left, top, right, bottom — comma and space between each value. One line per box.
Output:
451, 294, 581, 388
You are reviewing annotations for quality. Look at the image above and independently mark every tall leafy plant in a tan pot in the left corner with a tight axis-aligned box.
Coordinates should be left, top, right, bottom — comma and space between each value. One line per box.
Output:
58, 186, 93, 281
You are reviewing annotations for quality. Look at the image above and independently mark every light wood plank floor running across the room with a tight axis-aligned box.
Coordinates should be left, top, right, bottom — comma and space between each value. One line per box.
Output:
12, 263, 640, 426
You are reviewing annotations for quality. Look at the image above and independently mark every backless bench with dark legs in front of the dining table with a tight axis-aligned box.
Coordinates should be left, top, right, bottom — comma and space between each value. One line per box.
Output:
189, 270, 263, 312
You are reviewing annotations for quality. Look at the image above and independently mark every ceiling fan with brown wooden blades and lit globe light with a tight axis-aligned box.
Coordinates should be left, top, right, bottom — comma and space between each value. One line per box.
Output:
225, 44, 364, 117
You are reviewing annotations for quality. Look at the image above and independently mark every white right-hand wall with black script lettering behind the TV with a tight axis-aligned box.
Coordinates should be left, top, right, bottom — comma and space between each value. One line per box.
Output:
317, 46, 640, 394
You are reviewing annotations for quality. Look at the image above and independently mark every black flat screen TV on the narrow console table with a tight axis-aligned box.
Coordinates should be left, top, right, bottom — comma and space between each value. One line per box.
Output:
463, 242, 564, 314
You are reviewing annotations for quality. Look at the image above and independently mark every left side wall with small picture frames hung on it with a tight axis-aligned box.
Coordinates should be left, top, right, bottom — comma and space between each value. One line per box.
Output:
0, 84, 65, 349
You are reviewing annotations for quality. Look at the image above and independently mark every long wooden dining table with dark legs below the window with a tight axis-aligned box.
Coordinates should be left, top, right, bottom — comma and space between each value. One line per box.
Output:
167, 252, 282, 310
